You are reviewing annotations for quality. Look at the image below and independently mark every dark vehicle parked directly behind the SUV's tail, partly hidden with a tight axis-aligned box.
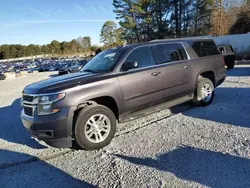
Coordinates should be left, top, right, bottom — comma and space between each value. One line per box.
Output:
219, 45, 235, 69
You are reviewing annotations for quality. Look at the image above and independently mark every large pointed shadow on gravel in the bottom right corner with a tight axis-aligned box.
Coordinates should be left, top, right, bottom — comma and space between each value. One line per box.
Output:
115, 147, 250, 188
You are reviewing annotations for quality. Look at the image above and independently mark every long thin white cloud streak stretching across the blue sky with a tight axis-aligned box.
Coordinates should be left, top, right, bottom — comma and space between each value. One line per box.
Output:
0, 19, 118, 28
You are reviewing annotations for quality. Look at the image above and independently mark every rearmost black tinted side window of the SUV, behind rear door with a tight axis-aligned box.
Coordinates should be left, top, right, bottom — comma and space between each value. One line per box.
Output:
188, 41, 220, 57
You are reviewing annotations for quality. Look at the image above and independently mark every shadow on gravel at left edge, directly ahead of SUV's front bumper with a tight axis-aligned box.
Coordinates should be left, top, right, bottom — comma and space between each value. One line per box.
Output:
0, 98, 45, 149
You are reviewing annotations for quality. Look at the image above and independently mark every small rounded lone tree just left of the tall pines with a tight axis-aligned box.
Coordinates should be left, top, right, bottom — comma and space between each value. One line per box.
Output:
100, 21, 117, 46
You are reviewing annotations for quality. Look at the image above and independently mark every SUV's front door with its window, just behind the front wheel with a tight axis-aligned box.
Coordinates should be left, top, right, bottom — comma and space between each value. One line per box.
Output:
118, 46, 163, 113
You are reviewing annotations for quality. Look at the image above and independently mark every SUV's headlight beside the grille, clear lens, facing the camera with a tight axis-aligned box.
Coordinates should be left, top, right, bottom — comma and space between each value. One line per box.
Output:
37, 93, 65, 115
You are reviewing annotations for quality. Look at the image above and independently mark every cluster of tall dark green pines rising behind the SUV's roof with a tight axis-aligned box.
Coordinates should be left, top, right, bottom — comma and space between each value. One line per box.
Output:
113, 0, 213, 43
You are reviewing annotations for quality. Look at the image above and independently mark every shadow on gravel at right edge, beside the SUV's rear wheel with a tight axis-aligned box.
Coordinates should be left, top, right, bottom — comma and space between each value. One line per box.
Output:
182, 88, 250, 128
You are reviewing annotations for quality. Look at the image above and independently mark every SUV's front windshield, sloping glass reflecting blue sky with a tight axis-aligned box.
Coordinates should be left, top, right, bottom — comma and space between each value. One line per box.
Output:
81, 49, 122, 72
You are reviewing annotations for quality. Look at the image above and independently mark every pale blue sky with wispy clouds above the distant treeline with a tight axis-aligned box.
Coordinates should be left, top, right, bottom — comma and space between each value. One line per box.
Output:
0, 0, 117, 45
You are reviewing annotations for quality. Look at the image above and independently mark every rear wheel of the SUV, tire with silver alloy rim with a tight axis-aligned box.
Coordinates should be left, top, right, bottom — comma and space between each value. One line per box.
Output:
193, 77, 214, 106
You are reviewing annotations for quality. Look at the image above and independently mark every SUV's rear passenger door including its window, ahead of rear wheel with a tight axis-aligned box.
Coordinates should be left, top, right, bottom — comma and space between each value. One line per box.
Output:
153, 43, 194, 99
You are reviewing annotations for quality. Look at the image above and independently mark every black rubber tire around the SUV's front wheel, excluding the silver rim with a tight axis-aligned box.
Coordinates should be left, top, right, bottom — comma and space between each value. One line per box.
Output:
74, 105, 116, 150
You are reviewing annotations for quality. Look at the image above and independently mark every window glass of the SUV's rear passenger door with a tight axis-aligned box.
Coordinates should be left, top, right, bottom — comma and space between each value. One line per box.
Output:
153, 43, 187, 64
